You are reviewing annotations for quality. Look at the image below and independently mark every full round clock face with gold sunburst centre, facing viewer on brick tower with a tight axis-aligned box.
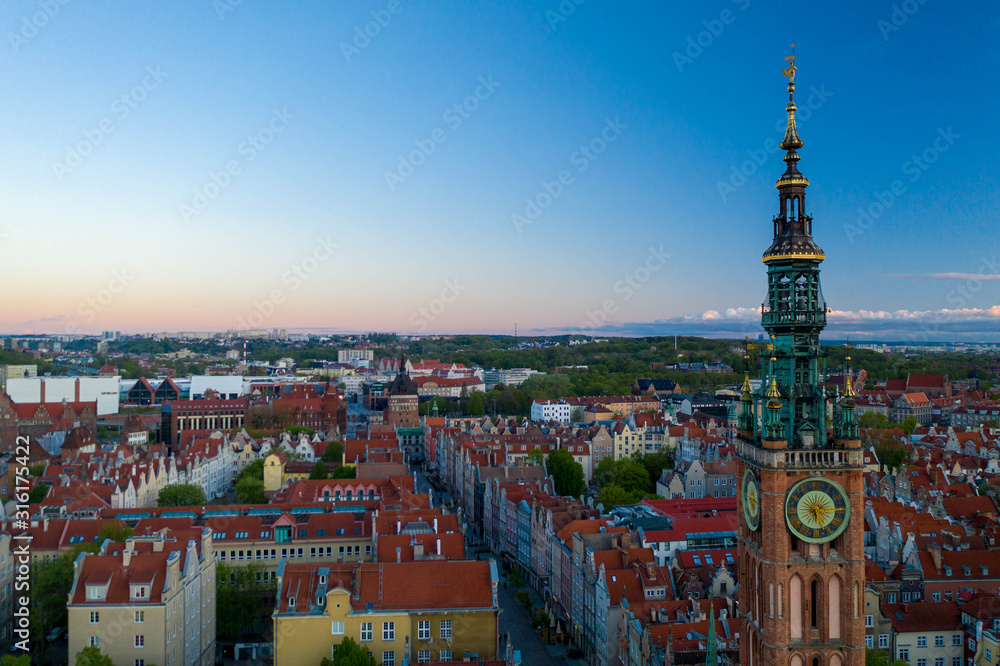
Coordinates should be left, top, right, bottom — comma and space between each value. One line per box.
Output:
785, 477, 851, 543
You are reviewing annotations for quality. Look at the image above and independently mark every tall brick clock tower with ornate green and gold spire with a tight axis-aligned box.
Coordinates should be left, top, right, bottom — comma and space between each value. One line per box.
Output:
736, 52, 865, 666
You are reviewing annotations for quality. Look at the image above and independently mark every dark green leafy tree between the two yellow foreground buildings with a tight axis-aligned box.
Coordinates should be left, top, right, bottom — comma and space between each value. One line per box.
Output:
215, 562, 278, 641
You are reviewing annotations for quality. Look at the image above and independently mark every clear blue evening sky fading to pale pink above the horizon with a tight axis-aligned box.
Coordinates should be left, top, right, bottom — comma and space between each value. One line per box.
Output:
0, 0, 1000, 341
